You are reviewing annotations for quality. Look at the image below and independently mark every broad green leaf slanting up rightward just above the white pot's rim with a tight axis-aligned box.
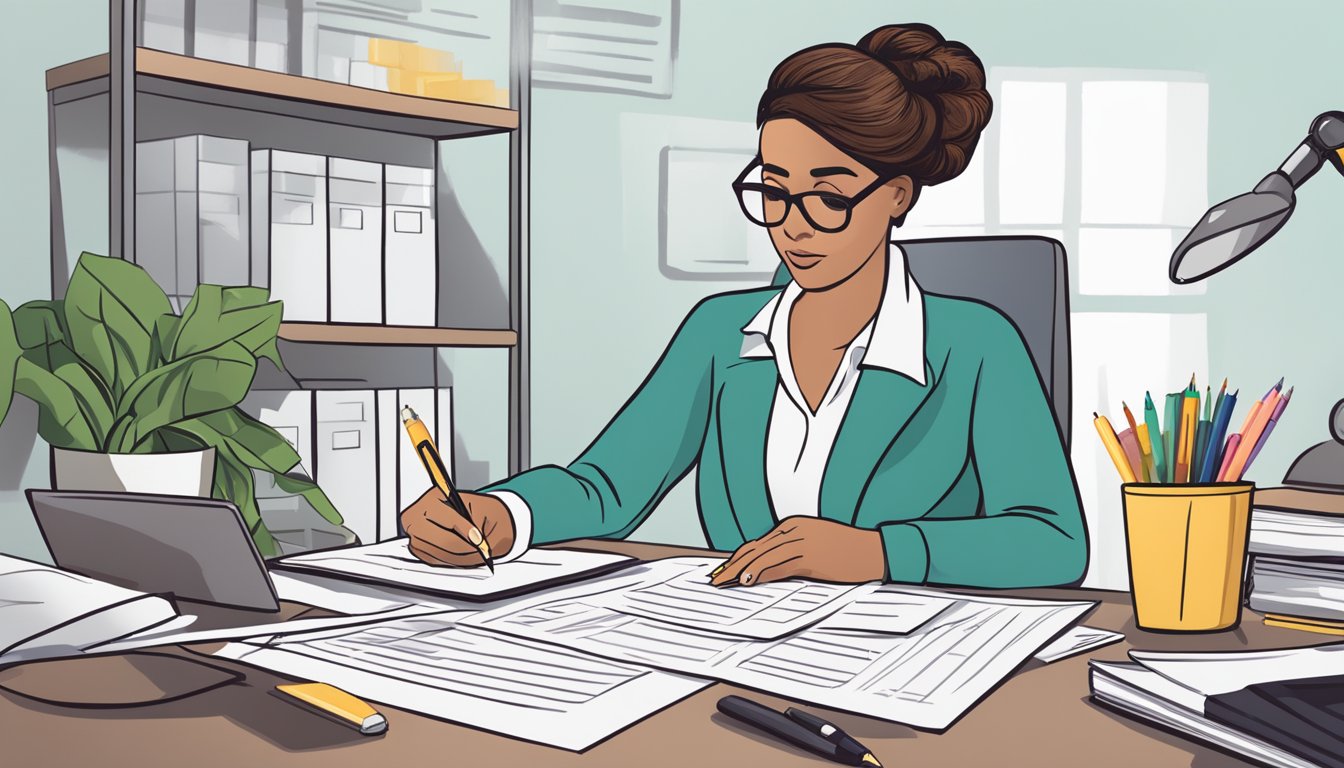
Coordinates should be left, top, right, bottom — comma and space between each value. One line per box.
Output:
108, 342, 257, 453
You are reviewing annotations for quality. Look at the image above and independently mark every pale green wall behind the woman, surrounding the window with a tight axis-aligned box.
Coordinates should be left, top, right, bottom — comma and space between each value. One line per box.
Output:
532, 0, 1344, 554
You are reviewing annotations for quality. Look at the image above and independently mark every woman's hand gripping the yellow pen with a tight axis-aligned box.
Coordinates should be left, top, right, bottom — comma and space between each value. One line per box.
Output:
402, 488, 516, 568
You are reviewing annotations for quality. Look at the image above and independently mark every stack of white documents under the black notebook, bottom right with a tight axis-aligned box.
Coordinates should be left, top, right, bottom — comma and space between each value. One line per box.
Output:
1090, 644, 1344, 768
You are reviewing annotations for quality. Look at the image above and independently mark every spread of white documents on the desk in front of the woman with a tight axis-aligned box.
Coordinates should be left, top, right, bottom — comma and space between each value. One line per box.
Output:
222, 548, 1096, 749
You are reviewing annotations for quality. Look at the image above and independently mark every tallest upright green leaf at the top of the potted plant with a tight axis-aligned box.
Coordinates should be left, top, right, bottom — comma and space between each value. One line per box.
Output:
65, 253, 172, 401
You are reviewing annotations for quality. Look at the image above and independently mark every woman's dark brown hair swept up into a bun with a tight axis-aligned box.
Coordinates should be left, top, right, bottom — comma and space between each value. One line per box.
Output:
757, 24, 993, 223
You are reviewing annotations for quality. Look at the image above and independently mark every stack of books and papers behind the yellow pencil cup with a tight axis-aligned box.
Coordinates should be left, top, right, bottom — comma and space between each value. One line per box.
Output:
1247, 488, 1344, 635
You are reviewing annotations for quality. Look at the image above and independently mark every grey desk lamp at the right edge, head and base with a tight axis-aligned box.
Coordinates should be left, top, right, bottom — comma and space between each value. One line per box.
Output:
1171, 112, 1344, 490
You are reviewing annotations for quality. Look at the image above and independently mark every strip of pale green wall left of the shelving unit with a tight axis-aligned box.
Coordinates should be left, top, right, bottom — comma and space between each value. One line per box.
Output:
0, 0, 108, 557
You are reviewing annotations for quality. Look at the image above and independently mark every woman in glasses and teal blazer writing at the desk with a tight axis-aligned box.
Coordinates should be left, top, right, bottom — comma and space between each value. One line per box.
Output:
402, 24, 1087, 588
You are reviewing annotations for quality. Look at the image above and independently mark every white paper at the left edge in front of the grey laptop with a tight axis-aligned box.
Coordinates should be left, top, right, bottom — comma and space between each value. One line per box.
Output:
0, 554, 177, 663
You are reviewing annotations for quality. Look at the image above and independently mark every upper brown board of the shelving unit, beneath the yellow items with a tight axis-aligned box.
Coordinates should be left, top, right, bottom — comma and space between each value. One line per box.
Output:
47, 48, 519, 139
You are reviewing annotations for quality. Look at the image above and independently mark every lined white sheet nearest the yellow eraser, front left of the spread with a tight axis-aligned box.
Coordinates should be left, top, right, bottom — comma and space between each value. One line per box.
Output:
219, 613, 710, 751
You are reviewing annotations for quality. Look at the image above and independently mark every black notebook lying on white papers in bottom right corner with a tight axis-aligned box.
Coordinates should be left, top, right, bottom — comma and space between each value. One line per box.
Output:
1204, 675, 1344, 768
